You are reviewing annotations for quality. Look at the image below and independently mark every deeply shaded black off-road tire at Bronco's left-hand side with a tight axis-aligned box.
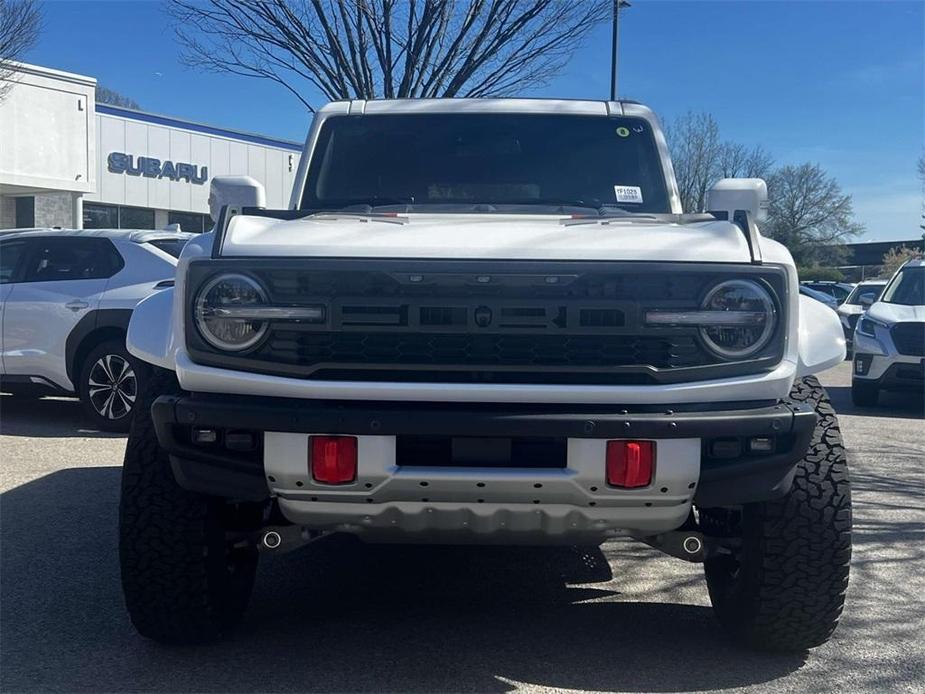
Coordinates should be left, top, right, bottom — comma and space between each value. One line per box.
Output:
119, 367, 259, 644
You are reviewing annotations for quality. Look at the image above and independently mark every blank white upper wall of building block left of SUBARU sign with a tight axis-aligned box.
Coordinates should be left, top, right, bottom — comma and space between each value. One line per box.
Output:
0, 63, 97, 193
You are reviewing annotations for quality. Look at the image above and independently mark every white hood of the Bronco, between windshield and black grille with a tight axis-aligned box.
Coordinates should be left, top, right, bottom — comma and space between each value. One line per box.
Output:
221, 214, 751, 263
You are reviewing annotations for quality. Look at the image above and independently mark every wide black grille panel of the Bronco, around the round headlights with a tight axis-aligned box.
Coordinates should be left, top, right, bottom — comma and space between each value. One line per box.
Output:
186, 258, 787, 385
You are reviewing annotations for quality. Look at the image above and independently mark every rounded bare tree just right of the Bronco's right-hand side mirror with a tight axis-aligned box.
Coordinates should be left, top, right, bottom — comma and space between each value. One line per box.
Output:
762, 164, 864, 266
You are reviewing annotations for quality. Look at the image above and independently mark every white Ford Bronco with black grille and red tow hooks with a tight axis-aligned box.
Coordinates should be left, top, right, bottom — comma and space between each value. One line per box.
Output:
120, 99, 851, 650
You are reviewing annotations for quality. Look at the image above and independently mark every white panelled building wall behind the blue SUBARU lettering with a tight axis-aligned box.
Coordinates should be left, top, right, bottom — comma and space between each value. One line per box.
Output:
84, 112, 299, 213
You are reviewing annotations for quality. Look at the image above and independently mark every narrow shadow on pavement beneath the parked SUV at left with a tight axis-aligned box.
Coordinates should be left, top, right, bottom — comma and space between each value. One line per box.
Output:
0, 395, 125, 438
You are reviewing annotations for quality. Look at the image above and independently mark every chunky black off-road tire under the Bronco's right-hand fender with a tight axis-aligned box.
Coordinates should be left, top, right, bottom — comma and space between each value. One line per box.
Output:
702, 377, 851, 651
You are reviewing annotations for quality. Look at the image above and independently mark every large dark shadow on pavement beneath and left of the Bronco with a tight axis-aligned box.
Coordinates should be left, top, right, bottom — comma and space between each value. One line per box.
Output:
0, 467, 805, 692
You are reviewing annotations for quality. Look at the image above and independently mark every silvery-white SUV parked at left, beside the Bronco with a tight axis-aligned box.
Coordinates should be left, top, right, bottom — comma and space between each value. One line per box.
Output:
0, 229, 192, 431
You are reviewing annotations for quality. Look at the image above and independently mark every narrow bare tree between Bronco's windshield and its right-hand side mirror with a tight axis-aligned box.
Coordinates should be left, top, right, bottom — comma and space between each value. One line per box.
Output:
666, 111, 722, 212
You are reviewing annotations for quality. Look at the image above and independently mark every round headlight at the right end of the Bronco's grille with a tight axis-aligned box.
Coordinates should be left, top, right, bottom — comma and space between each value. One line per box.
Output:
700, 280, 777, 359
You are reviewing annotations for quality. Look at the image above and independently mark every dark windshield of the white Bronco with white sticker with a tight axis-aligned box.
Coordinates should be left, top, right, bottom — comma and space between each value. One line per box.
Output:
301, 113, 671, 213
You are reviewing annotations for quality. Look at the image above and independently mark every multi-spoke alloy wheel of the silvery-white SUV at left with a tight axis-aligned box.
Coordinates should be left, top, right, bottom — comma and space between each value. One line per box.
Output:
78, 340, 140, 432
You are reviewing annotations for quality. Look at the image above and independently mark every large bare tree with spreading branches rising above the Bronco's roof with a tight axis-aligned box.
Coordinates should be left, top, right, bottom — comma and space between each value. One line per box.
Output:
169, 0, 610, 110
